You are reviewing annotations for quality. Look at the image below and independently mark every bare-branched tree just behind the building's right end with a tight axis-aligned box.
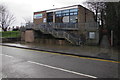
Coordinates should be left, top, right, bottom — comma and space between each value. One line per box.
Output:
85, 0, 106, 44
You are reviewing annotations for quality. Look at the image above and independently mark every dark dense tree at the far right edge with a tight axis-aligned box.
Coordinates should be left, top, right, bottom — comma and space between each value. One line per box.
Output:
105, 2, 120, 45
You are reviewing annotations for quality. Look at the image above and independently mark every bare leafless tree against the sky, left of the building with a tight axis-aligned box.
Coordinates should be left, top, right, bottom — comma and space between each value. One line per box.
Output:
0, 4, 15, 31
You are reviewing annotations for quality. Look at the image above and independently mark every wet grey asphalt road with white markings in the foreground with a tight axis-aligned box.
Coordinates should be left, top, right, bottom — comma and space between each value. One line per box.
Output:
0, 46, 119, 78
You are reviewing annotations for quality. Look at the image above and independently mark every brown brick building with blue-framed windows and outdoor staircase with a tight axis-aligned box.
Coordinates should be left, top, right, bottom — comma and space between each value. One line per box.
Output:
22, 5, 99, 45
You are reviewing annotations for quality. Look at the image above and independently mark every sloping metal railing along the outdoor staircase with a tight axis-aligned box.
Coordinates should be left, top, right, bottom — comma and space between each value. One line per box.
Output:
36, 24, 80, 45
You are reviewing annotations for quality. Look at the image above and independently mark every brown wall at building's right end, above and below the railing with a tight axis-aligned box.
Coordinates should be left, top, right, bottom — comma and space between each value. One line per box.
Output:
78, 6, 99, 45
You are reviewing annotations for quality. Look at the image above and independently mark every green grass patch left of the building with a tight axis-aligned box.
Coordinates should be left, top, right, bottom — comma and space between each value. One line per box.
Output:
0, 31, 20, 38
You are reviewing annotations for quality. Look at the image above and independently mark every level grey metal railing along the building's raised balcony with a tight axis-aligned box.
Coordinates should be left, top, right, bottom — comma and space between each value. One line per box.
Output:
19, 22, 99, 30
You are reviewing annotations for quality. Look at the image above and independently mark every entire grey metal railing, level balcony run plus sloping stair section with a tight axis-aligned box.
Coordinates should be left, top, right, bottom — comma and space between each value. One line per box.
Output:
19, 22, 98, 45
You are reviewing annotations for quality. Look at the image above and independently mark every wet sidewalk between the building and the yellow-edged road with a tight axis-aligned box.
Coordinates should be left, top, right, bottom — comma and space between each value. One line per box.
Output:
2, 43, 120, 61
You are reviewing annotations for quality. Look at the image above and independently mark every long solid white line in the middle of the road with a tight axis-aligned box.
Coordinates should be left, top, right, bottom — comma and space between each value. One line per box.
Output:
28, 61, 97, 78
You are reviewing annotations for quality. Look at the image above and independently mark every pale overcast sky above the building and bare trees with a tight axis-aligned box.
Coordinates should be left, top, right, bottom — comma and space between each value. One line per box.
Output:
0, 0, 85, 26
